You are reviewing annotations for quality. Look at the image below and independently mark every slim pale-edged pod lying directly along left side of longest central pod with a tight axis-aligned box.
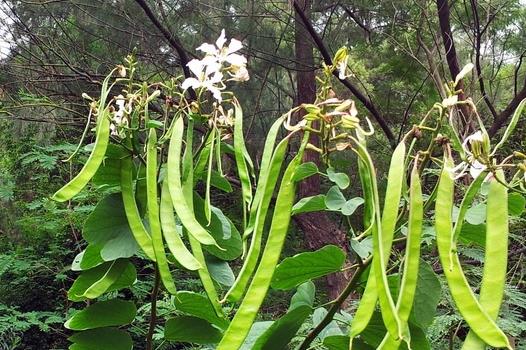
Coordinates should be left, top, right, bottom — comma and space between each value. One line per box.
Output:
225, 133, 290, 301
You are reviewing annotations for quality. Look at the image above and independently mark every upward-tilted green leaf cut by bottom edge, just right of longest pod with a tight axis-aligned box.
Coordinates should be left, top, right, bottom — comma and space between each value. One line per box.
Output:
253, 305, 312, 350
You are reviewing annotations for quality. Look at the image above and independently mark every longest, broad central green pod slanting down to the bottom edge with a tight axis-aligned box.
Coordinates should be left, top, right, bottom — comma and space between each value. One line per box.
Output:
216, 132, 309, 350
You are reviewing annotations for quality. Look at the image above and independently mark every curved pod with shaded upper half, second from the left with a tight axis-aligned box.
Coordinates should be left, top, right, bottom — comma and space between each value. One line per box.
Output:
121, 157, 155, 261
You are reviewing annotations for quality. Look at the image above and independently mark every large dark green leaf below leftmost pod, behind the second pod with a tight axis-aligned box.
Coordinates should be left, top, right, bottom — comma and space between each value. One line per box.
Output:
81, 193, 138, 260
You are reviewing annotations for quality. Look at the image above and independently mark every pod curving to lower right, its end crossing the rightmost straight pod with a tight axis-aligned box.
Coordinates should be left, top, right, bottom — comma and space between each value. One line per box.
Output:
435, 155, 511, 349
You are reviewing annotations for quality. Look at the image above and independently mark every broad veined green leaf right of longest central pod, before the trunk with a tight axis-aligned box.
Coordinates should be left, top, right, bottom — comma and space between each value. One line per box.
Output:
271, 245, 345, 290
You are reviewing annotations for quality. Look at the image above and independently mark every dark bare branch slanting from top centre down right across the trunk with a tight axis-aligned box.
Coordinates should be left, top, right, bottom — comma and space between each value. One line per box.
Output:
293, 0, 396, 147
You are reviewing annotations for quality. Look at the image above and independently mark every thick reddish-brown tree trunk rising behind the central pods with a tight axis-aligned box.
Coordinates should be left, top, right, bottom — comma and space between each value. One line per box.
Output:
295, 0, 348, 299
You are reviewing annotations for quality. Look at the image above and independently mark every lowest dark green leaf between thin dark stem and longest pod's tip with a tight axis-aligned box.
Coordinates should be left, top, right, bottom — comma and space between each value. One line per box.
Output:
164, 316, 222, 344
